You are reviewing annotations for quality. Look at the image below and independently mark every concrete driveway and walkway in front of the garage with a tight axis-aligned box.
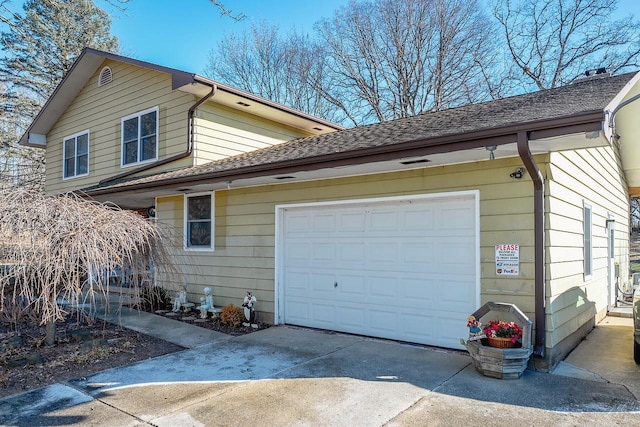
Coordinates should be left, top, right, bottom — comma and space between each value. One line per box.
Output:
0, 310, 640, 426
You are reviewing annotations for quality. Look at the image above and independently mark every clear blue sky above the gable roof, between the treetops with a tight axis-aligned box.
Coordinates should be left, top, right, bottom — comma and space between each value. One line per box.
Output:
109, 0, 348, 74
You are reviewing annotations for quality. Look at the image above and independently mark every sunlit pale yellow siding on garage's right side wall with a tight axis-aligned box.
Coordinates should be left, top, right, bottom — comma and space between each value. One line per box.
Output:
546, 147, 629, 347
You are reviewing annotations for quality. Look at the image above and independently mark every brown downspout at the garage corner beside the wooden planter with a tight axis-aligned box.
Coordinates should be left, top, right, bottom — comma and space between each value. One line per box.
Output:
518, 131, 547, 357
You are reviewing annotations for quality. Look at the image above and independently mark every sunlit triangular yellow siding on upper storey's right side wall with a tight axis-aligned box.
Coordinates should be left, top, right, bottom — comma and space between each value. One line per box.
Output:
194, 103, 309, 164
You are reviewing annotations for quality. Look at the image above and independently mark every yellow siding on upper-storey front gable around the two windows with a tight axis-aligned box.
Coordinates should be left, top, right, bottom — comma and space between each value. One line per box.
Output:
46, 61, 195, 193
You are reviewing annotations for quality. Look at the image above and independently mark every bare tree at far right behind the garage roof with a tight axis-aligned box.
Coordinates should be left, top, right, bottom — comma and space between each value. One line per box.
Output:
493, 0, 640, 89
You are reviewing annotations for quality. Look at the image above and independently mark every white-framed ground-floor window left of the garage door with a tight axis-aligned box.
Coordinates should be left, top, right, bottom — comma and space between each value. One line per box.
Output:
184, 193, 214, 250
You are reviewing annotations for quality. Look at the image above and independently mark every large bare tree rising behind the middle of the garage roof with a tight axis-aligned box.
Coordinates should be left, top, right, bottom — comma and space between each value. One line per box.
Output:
316, 0, 495, 124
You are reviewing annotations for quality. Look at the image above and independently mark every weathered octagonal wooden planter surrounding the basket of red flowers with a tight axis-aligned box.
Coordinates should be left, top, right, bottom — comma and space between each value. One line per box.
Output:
465, 302, 533, 379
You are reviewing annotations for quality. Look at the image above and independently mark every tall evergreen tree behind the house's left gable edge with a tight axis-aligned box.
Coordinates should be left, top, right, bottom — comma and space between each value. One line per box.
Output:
0, 0, 117, 192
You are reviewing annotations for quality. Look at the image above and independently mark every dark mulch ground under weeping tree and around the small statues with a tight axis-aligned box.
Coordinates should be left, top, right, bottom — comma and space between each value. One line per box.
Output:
0, 311, 269, 398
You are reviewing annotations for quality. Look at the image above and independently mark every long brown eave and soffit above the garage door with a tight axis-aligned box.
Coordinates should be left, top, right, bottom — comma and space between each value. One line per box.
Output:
85, 111, 609, 202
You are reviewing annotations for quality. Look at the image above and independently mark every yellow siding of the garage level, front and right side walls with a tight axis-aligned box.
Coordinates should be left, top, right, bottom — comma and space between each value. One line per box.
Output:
158, 148, 628, 347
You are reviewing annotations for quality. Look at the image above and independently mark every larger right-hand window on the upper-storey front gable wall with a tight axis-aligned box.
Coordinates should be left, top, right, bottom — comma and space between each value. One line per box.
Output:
122, 107, 158, 166
